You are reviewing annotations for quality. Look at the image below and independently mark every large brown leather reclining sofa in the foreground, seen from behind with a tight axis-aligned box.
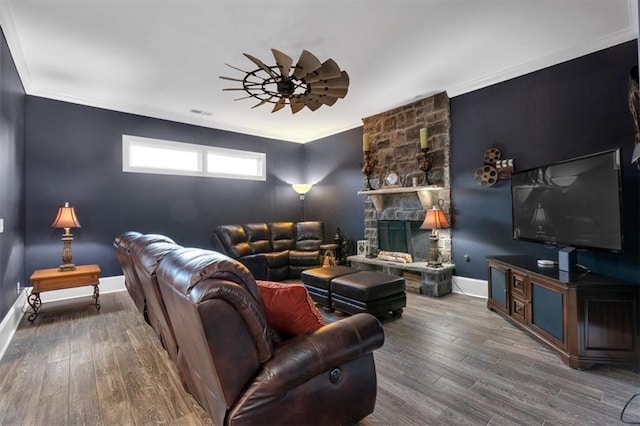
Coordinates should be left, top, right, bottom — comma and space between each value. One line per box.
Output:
115, 234, 384, 425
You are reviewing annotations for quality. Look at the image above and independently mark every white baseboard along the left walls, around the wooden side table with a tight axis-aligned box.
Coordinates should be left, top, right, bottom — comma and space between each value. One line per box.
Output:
0, 275, 127, 359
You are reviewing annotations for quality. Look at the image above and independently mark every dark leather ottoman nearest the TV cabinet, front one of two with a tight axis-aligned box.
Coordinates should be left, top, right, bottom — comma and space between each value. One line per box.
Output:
330, 271, 407, 316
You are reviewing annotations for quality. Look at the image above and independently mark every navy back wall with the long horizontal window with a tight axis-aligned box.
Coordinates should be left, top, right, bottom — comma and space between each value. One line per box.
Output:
25, 96, 303, 276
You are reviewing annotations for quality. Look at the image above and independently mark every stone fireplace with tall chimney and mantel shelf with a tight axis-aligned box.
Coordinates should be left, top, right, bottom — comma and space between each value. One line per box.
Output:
362, 92, 451, 262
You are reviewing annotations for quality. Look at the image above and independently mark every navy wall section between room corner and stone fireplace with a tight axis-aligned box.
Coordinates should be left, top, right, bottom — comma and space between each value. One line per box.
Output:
303, 127, 365, 250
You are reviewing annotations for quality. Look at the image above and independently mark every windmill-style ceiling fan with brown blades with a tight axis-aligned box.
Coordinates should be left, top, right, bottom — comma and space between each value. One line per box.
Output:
220, 49, 349, 114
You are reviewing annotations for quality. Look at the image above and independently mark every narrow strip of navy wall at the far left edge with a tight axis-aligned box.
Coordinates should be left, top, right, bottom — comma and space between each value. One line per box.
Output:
0, 27, 26, 320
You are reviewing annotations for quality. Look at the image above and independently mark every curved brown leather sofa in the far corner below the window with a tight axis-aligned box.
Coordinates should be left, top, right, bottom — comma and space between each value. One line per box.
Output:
212, 221, 324, 281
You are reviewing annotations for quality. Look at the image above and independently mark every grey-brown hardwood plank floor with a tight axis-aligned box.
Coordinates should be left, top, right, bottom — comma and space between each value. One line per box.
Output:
0, 292, 640, 426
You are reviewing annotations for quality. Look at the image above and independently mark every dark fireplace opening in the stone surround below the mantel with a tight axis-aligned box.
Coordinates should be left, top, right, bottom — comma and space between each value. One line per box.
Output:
378, 220, 429, 262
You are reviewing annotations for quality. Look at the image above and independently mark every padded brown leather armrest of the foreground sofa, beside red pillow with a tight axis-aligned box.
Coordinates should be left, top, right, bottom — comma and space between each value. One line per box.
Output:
241, 313, 384, 399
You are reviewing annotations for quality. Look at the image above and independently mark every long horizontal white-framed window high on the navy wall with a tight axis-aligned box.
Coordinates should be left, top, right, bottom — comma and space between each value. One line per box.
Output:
122, 135, 267, 181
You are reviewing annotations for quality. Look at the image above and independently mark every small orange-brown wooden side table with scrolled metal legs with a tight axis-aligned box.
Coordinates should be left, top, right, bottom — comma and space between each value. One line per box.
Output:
27, 265, 100, 322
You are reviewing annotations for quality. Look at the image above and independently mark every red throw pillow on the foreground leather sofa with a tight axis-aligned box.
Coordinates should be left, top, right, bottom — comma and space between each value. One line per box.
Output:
256, 280, 327, 336
